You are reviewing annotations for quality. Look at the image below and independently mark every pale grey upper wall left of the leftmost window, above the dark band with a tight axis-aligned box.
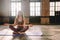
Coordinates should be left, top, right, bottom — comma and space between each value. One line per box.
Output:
1, 0, 10, 16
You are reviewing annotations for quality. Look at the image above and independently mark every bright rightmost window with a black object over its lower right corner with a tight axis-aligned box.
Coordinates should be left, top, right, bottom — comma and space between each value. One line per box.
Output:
50, 1, 60, 16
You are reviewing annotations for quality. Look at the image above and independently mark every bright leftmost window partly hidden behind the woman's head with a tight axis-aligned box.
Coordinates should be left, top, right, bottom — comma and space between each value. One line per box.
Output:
11, 0, 21, 16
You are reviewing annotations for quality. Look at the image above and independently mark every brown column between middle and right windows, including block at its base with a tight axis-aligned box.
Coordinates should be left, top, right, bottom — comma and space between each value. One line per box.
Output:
41, 0, 49, 24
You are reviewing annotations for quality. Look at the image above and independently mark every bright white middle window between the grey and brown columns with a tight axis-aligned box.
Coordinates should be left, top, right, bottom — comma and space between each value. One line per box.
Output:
30, 2, 40, 16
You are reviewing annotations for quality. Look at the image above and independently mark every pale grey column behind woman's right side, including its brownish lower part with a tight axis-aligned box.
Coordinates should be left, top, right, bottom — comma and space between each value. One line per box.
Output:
21, 0, 30, 23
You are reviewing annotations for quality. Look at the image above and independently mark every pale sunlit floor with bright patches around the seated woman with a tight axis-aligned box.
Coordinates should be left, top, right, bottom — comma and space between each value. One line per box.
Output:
0, 25, 60, 40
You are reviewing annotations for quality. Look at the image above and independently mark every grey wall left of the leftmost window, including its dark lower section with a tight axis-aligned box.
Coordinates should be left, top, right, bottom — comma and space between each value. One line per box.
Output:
0, 0, 10, 23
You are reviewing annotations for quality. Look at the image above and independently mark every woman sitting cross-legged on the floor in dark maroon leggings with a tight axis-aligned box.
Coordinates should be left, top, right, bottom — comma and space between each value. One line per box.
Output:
9, 12, 31, 34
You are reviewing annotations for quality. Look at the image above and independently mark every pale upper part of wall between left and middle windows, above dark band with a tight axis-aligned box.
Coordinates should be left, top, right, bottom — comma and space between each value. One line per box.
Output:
21, 0, 30, 16
